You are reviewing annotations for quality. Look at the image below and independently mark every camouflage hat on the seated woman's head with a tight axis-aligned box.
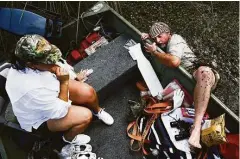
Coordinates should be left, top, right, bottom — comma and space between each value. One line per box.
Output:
15, 34, 62, 64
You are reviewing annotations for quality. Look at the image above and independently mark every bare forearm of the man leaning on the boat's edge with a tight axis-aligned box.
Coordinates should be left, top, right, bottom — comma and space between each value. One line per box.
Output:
151, 50, 181, 67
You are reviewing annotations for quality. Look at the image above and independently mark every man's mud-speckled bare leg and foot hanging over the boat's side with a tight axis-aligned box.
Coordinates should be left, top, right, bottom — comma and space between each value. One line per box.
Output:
188, 66, 215, 148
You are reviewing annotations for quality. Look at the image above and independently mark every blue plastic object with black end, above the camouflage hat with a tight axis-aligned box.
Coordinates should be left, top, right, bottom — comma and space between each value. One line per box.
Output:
0, 8, 62, 37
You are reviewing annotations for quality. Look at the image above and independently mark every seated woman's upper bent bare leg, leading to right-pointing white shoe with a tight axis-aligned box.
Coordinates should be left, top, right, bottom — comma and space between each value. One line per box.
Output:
69, 80, 101, 113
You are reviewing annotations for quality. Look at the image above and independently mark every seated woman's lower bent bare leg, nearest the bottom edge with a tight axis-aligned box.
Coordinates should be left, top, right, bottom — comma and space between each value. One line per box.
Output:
47, 106, 92, 141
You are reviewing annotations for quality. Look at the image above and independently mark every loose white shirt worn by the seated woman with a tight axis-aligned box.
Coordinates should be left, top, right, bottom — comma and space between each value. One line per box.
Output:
6, 68, 71, 132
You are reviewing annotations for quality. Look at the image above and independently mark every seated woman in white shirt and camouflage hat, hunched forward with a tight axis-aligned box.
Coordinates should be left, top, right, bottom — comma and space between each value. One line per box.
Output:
6, 35, 114, 151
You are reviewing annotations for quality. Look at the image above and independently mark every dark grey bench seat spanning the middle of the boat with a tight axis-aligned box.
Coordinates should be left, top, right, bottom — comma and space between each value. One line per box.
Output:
74, 35, 137, 100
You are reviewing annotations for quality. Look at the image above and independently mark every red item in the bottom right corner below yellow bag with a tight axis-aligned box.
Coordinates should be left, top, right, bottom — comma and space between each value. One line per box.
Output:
219, 134, 239, 159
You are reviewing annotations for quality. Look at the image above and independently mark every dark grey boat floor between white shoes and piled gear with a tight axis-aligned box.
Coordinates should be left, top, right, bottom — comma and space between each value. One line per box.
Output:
85, 82, 142, 159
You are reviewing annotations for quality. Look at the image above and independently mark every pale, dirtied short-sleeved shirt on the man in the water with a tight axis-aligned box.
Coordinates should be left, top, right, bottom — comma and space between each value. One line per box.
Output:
166, 34, 197, 68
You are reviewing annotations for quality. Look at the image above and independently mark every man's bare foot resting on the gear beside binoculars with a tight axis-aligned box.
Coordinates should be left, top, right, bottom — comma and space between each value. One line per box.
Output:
188, 127, 202, 149
